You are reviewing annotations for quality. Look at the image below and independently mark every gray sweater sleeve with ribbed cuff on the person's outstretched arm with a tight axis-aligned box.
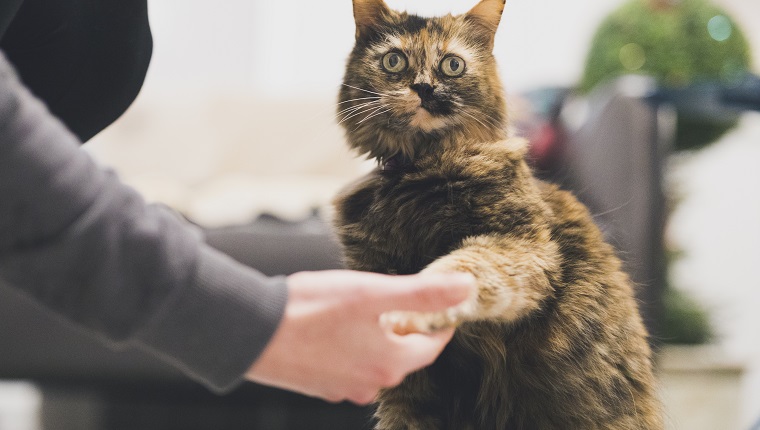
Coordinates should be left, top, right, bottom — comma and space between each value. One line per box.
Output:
0, 53, 287, 392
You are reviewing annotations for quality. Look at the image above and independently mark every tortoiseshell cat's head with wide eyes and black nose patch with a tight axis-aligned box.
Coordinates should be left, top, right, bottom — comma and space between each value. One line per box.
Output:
338, 0, 506, 160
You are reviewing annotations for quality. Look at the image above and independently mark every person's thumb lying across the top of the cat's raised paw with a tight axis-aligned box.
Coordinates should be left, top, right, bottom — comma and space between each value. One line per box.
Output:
374, 272, 475, 313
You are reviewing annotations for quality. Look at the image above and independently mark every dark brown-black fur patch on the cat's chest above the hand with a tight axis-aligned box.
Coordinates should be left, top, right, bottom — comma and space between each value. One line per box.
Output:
339, 171, 472, 274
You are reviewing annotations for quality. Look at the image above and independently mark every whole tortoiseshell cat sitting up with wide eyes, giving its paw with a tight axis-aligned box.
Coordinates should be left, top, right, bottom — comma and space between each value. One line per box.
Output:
335, 0, 662, 430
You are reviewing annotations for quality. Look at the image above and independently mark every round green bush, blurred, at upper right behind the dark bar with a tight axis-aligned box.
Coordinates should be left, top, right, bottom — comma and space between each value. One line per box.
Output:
579, 0, 751, 150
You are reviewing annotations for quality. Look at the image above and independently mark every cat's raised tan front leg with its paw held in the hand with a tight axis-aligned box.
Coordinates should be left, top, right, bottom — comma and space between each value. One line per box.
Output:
381, 231, 559, 334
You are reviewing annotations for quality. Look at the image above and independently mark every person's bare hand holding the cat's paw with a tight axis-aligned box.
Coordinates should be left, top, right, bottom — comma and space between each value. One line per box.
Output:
246, 270, 474, 404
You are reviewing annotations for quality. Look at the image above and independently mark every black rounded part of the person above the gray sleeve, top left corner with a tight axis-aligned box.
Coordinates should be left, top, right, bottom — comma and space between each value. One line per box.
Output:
0, 0, 153, 142
